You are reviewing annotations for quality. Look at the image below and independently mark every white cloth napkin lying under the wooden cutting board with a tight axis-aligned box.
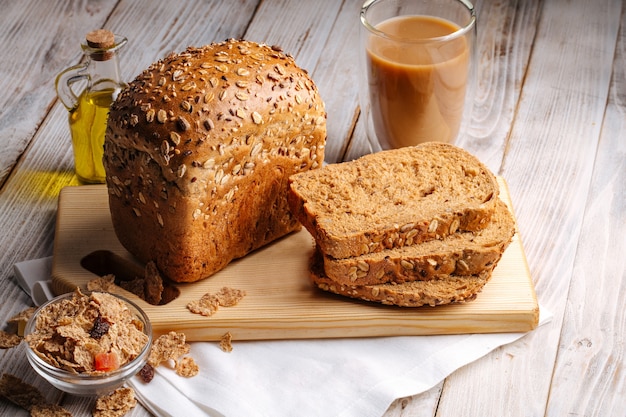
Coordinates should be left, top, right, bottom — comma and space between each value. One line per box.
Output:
16, 261, 552, 417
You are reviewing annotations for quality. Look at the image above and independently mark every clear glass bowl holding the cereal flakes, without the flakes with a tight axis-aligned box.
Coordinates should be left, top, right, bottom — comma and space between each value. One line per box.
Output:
24, 293, 152, 396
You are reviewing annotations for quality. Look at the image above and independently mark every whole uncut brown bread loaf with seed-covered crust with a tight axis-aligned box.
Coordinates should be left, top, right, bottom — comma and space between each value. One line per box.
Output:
103, 40, 326, 282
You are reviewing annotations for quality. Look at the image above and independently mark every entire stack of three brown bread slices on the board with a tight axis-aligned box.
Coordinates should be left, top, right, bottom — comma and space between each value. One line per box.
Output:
288, 142, 515, 307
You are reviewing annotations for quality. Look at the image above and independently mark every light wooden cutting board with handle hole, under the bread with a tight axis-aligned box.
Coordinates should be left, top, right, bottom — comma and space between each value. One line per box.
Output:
52, 178, 539, 341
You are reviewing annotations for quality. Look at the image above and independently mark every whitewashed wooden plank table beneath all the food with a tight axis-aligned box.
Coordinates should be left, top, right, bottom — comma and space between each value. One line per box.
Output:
0, 0, 626, 417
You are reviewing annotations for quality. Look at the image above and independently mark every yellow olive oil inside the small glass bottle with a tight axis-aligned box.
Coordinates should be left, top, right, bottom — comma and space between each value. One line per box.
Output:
69, 88, 116, 183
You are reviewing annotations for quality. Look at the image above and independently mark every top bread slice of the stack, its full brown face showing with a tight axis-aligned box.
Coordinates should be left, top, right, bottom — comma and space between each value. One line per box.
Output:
288, 142, 499, 259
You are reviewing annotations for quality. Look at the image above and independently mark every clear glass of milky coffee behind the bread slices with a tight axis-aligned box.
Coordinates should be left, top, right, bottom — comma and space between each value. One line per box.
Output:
360, 0, 476, 151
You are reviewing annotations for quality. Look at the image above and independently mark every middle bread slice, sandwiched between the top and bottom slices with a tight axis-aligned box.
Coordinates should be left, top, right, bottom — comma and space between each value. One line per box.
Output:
323, 201, 515, 285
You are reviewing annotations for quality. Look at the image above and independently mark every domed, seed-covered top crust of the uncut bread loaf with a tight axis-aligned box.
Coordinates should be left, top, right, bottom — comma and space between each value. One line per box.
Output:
107, 39, 326, 192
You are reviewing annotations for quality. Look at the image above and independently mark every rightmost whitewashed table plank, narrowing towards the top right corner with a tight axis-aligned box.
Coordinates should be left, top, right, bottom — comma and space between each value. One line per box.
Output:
546, 3, 626, 416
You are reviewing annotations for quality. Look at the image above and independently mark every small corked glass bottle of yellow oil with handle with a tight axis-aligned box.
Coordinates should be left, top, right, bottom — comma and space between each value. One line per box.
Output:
56, 30, 126, 183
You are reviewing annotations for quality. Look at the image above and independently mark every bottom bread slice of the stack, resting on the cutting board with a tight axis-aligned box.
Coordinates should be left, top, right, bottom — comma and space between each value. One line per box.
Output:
310, 248, 494, 307
